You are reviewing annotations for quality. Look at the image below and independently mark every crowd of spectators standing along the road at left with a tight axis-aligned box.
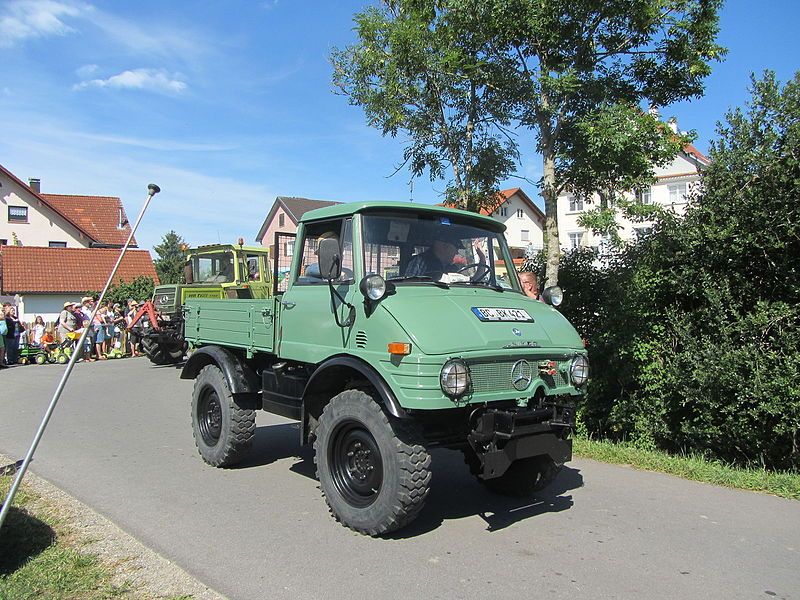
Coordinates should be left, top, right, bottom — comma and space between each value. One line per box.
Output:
0, 296, 148, 368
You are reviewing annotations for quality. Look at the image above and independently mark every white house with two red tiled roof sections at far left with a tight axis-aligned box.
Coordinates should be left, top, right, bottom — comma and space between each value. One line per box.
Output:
0, 165, 158, 321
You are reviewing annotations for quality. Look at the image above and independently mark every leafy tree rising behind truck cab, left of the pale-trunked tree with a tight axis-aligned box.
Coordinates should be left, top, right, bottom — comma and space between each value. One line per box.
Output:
331, 0, 517, 212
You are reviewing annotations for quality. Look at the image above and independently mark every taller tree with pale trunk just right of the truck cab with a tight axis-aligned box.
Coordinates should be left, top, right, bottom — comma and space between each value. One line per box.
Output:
484, 0, 725, 285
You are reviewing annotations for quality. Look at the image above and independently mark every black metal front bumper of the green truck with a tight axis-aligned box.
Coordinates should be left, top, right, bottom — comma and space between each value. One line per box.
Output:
467, 407, 572, 479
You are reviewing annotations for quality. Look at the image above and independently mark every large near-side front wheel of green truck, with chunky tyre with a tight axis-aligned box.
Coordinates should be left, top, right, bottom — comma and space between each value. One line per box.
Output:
314, 390, 431, 536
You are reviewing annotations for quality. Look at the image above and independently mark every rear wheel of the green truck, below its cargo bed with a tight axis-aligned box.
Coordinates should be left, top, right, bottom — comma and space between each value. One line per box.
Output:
192, 365, 256, 467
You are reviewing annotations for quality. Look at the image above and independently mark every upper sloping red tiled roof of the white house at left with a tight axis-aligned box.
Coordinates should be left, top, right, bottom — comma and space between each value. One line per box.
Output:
39, 194, 136, 246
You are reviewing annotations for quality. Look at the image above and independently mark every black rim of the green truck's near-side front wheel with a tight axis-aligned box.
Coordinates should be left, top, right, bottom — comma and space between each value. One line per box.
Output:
328, 421, 383, 508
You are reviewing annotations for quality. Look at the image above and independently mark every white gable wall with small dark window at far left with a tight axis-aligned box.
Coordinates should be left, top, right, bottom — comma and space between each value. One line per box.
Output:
0, 175, 89, 248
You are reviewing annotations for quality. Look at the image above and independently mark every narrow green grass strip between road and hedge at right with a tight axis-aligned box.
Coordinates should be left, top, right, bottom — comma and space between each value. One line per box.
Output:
573, 437, 800, 500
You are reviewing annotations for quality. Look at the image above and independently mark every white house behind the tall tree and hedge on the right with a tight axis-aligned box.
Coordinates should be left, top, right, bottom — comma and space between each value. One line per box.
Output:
558, 119, 710, 249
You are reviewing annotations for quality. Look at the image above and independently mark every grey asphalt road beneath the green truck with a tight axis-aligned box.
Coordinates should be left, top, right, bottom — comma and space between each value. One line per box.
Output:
0, 359, 800, 600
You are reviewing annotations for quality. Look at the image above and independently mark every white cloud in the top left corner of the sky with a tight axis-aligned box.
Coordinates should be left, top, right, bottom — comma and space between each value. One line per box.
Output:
0, 0, 86, 47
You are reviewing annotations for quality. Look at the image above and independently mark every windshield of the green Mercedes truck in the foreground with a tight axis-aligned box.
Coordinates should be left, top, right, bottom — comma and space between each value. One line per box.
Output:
362, 213, 519, 290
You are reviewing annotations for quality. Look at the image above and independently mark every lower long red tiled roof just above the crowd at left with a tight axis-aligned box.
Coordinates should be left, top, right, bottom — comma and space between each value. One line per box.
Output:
0, 246, 158, 294
